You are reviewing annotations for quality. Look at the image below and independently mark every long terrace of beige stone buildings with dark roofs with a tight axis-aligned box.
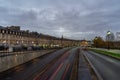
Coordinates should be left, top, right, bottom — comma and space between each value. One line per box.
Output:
0, 26, 79, 46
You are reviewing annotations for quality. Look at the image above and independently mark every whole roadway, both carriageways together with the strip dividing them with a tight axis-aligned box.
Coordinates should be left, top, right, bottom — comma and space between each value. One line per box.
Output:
0, 47, 120, 80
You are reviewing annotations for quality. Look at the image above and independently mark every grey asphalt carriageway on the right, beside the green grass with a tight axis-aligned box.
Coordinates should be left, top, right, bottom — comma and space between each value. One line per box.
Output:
83, 51, 120, 80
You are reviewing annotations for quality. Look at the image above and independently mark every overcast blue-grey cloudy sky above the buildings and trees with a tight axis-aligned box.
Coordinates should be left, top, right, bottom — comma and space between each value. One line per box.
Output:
0, 0, 120, 40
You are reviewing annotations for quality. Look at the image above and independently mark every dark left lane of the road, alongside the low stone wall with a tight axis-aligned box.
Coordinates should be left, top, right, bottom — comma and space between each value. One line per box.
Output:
0, 48, 69, 80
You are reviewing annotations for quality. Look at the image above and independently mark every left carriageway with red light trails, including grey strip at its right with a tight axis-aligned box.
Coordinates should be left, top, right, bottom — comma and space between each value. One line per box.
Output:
0, 47, 92, 80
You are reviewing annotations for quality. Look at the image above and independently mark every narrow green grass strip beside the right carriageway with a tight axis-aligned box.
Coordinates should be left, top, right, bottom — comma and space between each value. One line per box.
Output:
90, 49, 120, 59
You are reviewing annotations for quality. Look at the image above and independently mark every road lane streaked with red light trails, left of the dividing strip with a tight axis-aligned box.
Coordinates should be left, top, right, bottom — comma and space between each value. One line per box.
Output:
34, 48, 78, 80
